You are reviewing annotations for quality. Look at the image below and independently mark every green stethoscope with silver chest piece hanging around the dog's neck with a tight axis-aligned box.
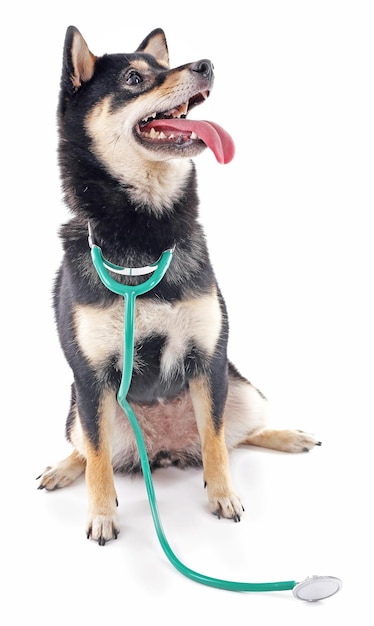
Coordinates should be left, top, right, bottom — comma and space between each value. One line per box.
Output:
88, 225, 342, 602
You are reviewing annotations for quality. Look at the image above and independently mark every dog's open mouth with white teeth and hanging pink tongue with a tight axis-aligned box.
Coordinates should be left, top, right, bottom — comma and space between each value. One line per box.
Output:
135, 91, 235, 163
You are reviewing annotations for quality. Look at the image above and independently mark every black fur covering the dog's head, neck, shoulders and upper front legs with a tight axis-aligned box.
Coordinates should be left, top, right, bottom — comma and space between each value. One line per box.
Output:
54, 29, 228, 445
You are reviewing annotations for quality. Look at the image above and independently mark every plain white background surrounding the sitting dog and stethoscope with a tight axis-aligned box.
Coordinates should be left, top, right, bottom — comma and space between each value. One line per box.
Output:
0, 0, 374, 626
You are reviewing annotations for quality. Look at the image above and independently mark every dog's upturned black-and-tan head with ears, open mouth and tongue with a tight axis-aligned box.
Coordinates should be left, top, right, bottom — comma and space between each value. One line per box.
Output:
59, 26, 234, 210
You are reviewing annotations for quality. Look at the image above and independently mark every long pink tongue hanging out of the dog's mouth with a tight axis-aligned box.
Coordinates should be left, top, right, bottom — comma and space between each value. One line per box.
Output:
142, 118, 235, 163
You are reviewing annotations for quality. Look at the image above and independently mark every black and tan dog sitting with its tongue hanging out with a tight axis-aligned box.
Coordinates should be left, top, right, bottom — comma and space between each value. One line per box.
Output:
38, 26, 320, 545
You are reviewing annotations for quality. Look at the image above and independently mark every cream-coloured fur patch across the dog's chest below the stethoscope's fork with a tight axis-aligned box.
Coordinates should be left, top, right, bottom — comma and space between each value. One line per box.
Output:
74, 290, 222, 379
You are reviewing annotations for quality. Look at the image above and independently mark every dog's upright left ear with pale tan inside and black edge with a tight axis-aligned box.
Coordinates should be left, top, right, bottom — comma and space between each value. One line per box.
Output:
64, 26, 97, 90
